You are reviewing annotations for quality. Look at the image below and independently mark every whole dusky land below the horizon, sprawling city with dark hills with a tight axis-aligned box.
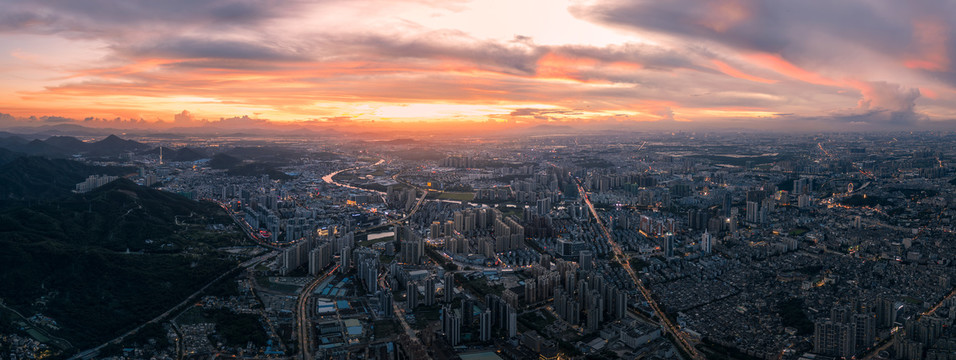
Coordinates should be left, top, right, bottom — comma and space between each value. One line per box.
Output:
0, 130, 956, 360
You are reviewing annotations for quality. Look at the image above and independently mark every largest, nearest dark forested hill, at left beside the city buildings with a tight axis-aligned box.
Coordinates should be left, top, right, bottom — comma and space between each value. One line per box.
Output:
0, 177, 241, 348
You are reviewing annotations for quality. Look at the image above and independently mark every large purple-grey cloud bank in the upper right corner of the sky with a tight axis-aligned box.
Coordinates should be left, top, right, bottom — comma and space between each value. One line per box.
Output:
572, 0, 956, 84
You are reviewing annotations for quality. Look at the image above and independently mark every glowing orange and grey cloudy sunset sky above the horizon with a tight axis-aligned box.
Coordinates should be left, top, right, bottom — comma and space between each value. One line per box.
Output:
0, 0, 956, 130
